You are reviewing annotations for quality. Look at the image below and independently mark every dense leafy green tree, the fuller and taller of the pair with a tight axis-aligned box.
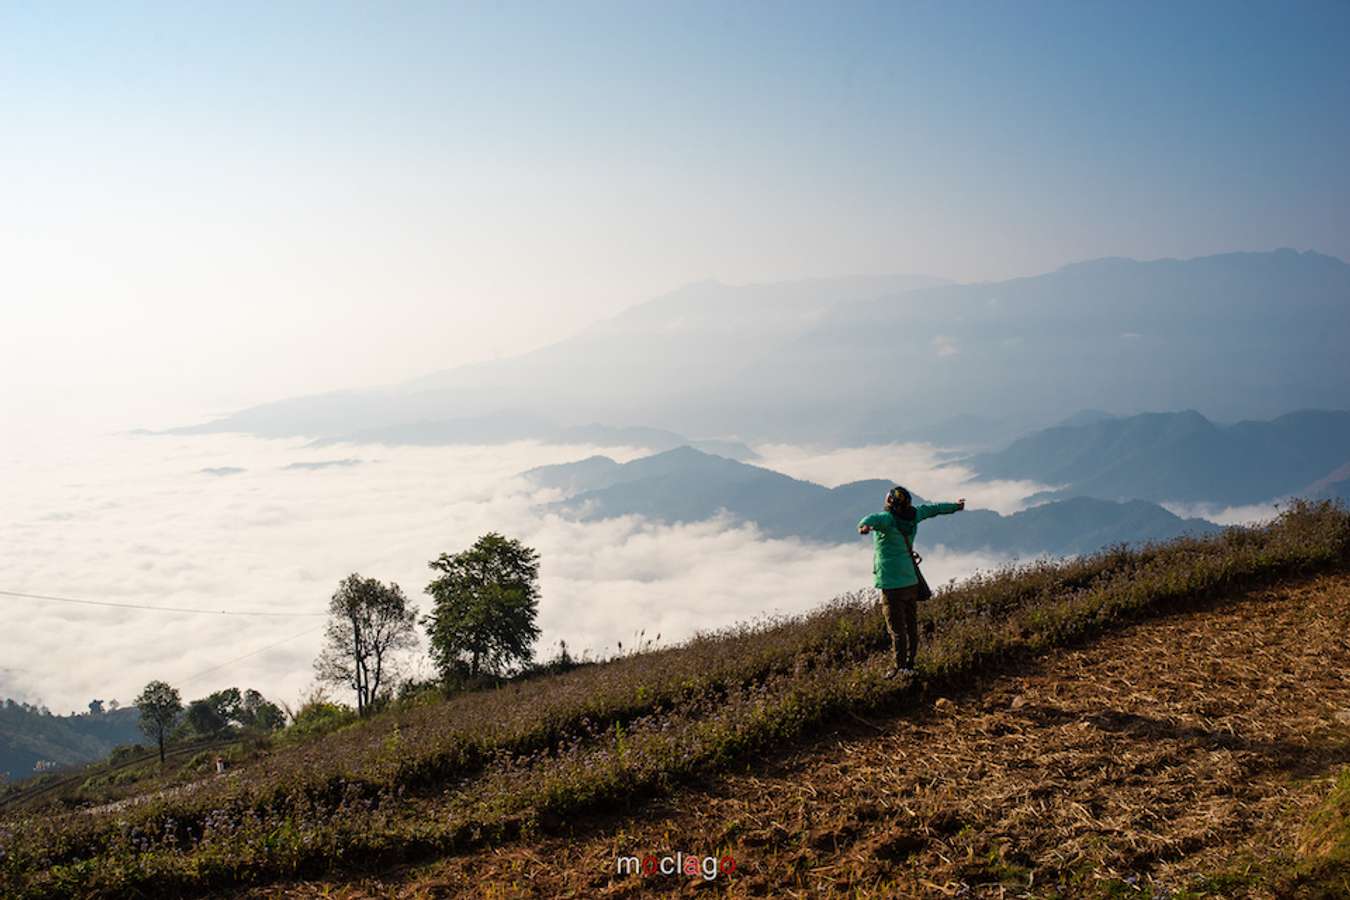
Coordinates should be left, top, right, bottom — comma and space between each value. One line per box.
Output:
423, 532, 539, 679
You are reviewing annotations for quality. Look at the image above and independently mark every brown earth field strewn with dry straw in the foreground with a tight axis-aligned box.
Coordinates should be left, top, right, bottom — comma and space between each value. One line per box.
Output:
252, 573, 1350, 897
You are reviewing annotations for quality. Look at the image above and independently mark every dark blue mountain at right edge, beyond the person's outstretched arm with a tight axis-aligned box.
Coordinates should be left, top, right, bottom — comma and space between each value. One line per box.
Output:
963, 410, 1350, 505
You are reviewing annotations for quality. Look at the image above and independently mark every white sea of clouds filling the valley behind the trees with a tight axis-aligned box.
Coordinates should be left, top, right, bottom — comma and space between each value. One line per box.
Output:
0, 434, 1040, 711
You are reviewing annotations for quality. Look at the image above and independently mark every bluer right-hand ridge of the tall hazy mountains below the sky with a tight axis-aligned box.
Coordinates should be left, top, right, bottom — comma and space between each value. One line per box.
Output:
759, 250, 1350, 443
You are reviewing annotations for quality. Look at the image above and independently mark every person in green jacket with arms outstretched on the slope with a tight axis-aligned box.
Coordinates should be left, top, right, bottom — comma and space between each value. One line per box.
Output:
857, 487, 965, 679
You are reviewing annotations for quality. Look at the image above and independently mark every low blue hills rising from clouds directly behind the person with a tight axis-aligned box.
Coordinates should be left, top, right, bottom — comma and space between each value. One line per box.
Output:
525, 447, 1219, 556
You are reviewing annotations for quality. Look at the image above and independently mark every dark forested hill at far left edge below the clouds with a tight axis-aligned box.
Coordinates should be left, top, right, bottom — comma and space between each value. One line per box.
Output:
0, 700, 142, 781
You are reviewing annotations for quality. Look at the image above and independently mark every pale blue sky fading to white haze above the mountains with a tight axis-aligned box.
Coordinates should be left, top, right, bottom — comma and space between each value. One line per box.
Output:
0, 3, 1350, 429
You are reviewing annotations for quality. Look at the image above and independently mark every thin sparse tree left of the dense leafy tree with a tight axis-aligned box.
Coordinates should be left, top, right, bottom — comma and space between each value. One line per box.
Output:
315, 573, 417, 715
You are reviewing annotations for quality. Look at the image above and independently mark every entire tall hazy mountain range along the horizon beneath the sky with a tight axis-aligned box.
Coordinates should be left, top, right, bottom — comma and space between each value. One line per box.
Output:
174, 250, 1350, 447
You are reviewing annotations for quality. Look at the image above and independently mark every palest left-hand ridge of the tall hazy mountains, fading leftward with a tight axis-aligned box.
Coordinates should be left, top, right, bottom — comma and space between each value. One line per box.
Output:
174, 275, 944, 443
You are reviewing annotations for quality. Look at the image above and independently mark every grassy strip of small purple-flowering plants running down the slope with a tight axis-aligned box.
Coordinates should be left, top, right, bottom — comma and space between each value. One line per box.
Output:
0, 503, 1350, 896
